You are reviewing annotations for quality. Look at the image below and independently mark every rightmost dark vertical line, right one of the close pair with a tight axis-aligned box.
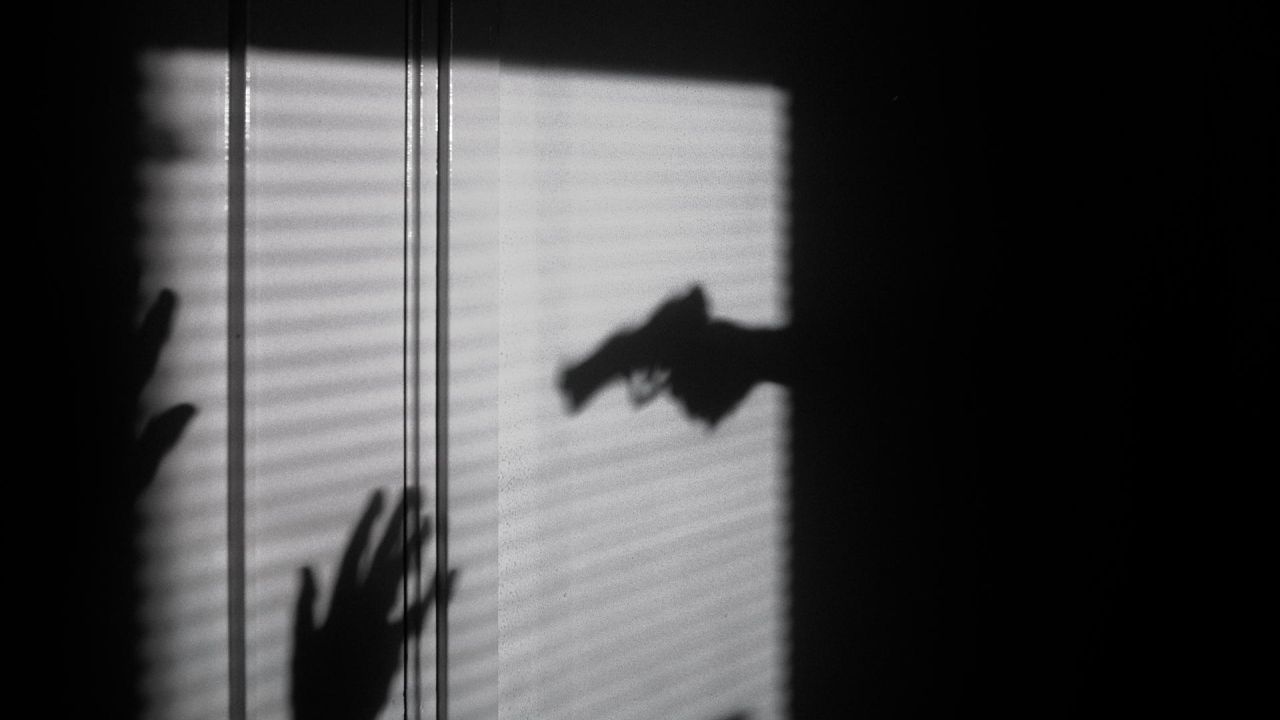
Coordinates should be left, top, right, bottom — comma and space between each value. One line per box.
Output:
435, 0, 453, 720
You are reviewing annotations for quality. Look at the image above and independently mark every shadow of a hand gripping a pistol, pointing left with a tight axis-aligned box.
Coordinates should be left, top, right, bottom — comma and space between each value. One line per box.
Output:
559, 286, 795, 428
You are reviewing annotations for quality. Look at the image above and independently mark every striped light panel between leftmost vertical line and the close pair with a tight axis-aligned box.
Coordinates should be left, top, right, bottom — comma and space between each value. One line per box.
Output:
246, 49, 434, 717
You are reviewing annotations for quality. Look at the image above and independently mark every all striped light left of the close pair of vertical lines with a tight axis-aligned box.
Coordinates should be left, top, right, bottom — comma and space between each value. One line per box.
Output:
135, 49, 435, 720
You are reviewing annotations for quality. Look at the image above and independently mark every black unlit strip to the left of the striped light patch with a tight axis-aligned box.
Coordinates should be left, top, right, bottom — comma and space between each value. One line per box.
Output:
31, 3, 227, 717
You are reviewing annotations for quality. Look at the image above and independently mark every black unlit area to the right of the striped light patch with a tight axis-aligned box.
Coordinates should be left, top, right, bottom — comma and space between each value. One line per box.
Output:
788, 3, 1275, 717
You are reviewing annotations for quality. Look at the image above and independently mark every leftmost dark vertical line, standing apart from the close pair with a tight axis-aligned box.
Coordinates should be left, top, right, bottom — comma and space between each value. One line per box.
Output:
227, 0, 248, 720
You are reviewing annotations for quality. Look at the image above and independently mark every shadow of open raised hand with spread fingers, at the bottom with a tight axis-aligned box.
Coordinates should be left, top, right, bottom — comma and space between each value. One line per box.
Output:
291, 491, 457, 720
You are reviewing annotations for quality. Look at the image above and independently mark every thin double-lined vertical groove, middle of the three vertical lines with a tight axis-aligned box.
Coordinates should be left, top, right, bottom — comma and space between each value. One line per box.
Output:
402, 0, 422, 720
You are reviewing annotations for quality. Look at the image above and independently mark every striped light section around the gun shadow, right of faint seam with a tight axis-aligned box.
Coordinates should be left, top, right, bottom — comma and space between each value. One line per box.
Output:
491, 67, 787, 720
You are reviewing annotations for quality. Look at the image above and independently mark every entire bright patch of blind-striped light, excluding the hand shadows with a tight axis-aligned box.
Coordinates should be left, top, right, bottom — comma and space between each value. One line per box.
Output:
140, 49, 788, 720
